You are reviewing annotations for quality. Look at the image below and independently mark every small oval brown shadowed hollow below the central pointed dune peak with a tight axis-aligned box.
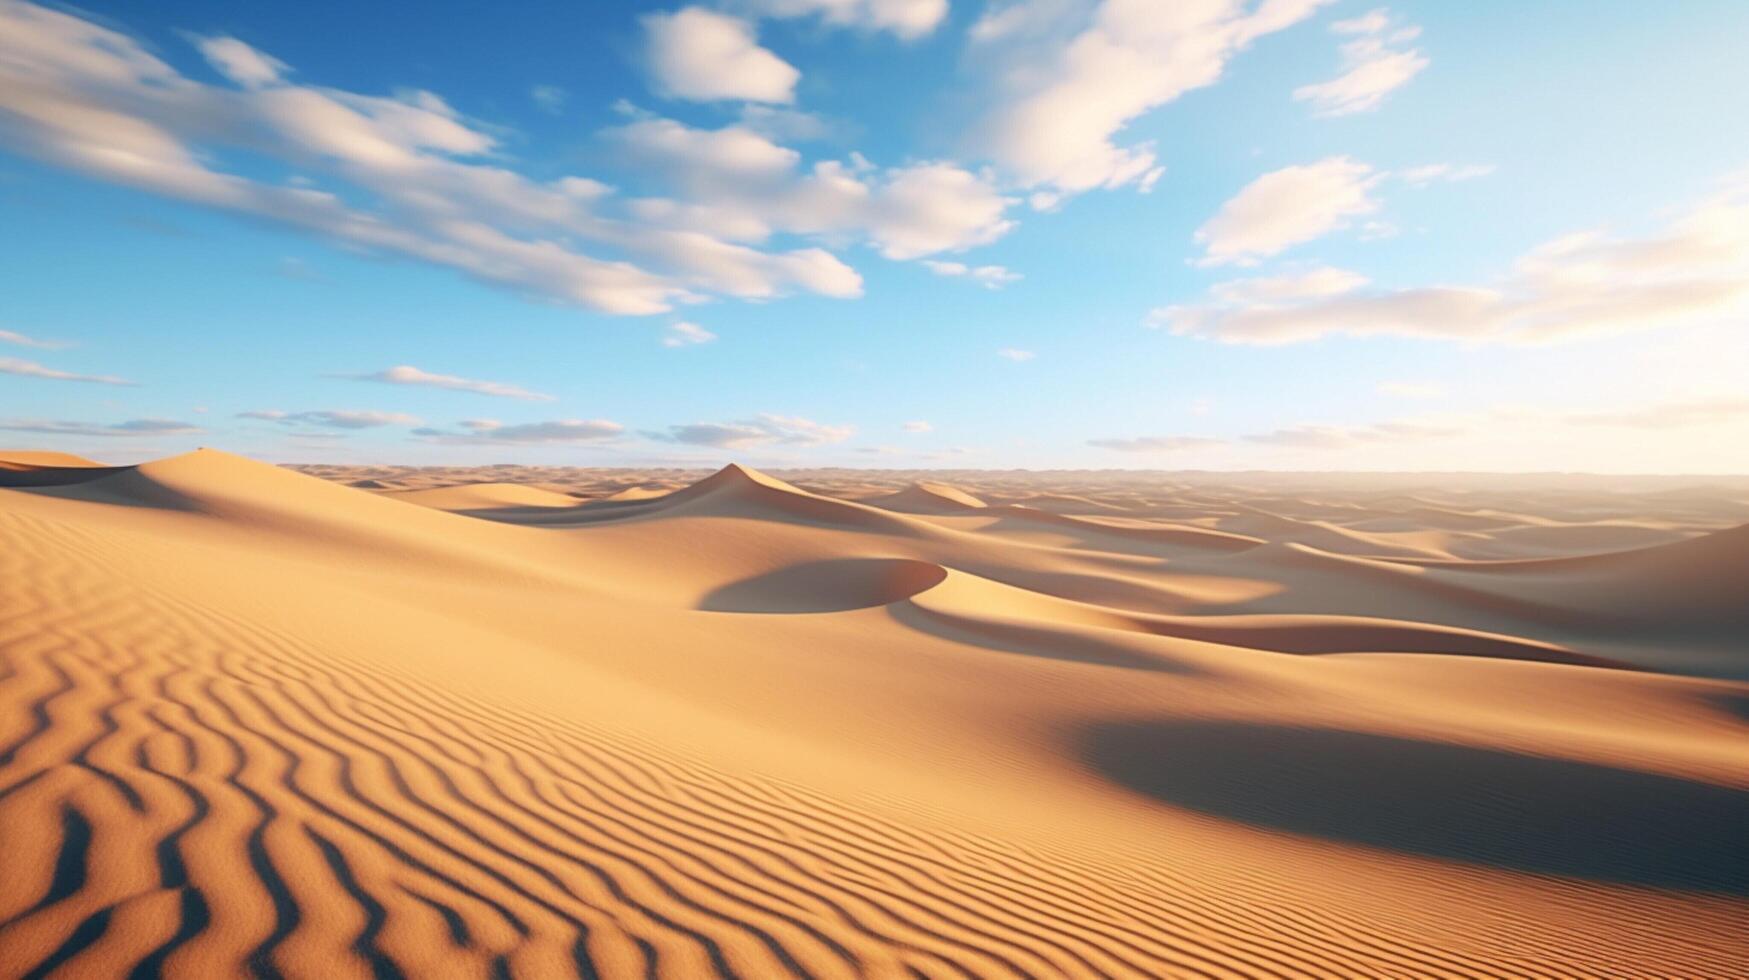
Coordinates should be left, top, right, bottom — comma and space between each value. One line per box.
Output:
698, 558, 948, 613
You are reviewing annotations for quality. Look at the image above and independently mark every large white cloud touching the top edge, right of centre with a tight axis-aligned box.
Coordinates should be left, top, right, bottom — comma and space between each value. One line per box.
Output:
972, 0, 1324, 193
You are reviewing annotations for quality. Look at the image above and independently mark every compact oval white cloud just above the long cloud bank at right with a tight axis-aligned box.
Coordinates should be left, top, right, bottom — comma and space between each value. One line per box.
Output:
1196, 156, 1380, 266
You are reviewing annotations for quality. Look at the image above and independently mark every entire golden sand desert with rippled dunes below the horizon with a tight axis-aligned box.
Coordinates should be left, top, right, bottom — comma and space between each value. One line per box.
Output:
0, 450, 1749, 978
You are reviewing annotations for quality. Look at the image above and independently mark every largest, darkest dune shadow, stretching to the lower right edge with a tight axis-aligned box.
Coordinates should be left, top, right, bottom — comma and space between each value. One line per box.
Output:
1081, 721, 1749, 896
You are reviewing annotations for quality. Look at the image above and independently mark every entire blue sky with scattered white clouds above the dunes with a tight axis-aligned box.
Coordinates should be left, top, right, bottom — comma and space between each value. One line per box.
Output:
0, 0, 1749, 473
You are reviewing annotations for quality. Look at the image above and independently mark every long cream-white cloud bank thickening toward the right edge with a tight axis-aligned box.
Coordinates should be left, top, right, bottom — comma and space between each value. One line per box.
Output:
1149, 179, 1749, 345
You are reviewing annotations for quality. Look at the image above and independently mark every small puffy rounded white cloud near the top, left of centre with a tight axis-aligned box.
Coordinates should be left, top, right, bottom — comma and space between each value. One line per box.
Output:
644, 7, 801, 102
